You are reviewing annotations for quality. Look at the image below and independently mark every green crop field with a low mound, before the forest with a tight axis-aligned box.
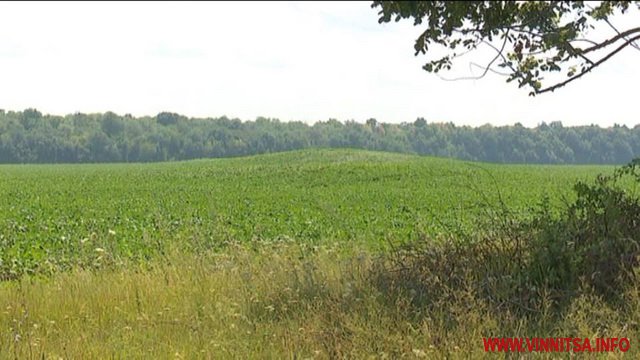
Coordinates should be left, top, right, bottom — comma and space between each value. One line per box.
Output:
0, 150, 613, 277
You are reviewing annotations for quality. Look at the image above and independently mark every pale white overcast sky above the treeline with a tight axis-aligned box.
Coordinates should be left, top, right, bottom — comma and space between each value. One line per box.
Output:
0, 2, 640, 127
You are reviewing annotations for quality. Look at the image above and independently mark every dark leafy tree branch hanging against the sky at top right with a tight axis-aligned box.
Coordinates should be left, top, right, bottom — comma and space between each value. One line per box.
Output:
372, 1, 640, 96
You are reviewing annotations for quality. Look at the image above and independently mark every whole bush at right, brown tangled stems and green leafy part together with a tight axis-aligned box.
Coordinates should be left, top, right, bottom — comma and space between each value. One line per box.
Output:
374, 159, 640, 320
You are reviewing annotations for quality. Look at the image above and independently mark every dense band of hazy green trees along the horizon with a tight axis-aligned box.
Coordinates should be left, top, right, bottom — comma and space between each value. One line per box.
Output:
0, 109, 640, 164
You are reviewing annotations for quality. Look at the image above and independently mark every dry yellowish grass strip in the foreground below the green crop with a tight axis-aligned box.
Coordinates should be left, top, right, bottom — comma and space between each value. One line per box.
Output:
0, 245, 640, 359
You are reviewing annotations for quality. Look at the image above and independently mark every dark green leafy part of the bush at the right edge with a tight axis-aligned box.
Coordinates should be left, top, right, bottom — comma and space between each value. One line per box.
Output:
528, 159, 640, 299
